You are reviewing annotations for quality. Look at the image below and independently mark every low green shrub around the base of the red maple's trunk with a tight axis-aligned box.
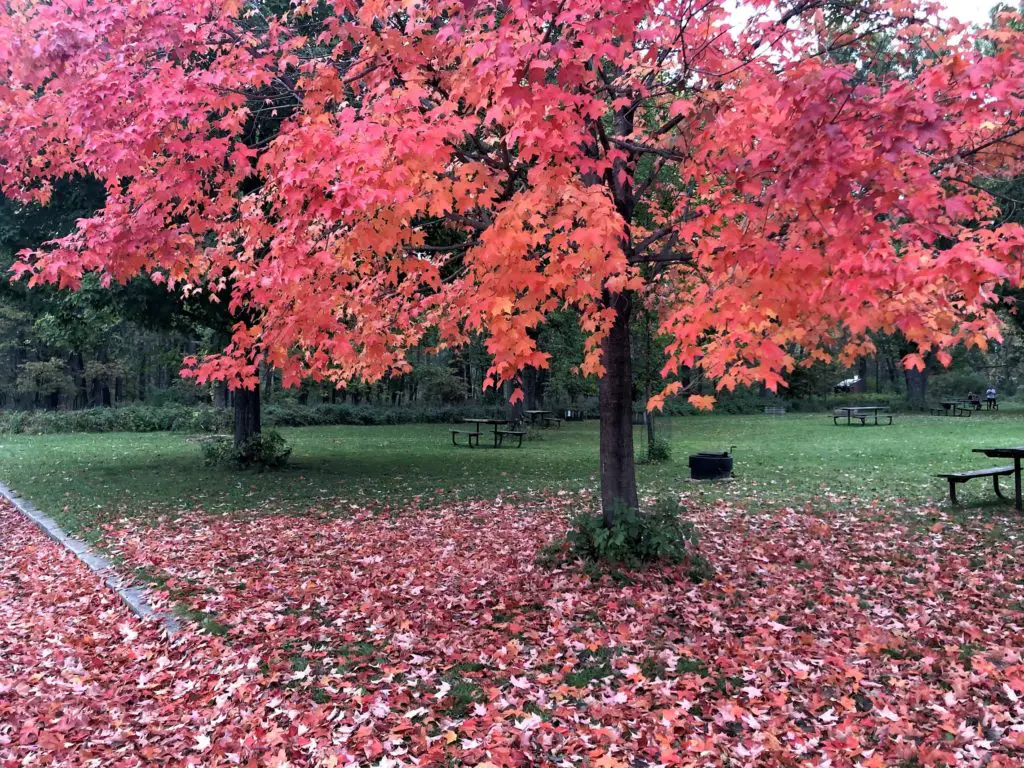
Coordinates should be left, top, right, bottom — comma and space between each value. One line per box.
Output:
539, 499, 711, 581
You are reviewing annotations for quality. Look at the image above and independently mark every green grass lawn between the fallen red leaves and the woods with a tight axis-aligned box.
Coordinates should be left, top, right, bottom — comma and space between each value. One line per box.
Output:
0, 412, 1024, 538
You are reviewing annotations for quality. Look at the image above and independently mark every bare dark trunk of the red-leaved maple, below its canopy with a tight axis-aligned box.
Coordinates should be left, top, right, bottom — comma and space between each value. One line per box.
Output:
599, 294, 639, 527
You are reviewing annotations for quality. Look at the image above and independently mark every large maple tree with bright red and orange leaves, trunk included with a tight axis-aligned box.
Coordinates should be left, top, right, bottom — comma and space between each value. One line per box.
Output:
0, 0, 1024, 522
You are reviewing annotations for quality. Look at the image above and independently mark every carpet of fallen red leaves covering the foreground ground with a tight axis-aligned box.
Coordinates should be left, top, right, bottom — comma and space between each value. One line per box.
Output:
6, 496, 1024, 768
